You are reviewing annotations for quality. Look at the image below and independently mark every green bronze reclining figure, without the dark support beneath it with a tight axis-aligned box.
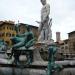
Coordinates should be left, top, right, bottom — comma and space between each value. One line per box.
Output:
11, 26, 34, 49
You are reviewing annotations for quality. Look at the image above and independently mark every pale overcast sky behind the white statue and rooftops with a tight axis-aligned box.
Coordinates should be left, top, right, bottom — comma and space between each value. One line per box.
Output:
0, 0, 75, 40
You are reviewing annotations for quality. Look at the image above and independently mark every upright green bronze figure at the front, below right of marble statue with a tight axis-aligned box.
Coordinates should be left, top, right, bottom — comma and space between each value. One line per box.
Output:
47, 44, 62, 75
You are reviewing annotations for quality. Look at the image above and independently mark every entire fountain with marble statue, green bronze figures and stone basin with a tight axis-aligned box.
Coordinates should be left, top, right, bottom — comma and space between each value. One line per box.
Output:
0, 0, 75, 75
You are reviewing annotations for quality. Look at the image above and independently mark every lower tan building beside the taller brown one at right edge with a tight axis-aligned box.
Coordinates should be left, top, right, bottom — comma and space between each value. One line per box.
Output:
56, 39, 69, 60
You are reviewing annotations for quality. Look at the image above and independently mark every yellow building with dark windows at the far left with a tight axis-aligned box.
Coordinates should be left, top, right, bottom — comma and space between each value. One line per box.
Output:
0, 21, 16, 45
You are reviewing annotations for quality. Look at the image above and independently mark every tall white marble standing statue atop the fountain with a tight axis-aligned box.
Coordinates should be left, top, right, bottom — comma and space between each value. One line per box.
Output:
38, 0, 52, 42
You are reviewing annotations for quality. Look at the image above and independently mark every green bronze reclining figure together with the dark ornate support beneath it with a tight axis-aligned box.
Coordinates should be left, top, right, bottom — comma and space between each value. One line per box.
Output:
11, 26, 35, 64
